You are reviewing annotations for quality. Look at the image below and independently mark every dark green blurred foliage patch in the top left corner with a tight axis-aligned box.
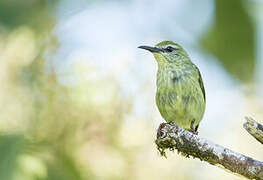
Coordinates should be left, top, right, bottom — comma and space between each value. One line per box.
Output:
0, 0, 58, 30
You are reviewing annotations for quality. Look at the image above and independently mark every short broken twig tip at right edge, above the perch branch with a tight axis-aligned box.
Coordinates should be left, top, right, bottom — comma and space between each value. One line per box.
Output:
243, 117, 263, 144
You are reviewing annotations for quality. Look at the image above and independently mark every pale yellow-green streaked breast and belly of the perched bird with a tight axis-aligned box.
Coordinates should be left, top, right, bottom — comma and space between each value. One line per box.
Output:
155, 67, 204, 125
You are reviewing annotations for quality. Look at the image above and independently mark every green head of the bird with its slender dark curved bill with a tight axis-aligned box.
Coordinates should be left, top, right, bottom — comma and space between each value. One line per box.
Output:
138, 41, 189, 64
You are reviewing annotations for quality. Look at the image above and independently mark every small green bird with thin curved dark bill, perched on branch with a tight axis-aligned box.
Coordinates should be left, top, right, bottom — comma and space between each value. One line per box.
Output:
138, 41, 206, 134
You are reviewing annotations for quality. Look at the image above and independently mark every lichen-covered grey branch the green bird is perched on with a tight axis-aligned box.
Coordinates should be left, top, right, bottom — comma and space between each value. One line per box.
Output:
155, 123, 263, 180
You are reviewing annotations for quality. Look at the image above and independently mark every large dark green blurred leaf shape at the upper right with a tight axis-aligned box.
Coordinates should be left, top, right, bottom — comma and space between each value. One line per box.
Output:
201, 0, 255, 82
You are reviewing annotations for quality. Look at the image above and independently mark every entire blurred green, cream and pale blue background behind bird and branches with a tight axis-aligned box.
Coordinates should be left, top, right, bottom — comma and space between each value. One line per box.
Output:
0, 0, 263, 180
